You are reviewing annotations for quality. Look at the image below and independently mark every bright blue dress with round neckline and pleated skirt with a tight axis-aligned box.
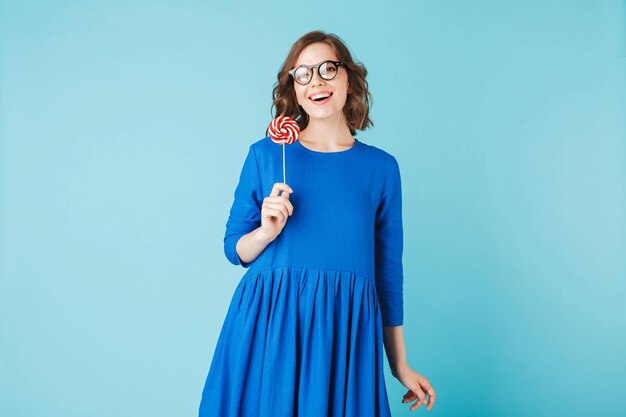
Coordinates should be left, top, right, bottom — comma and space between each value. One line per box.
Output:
199, 138, 403, 417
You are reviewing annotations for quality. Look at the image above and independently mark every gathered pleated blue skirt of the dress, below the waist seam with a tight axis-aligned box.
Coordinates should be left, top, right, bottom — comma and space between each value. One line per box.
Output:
200, 267, 390, 417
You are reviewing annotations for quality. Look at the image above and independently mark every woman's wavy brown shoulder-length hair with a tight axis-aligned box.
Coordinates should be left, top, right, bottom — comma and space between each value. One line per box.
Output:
272, 30, 374, 135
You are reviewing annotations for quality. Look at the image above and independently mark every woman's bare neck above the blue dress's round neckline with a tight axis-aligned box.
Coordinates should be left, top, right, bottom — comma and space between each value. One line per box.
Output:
298, 117, 354, 152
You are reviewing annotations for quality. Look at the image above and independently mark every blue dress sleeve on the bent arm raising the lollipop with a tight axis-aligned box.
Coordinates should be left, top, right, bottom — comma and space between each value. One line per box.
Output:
224, 145, 264, 268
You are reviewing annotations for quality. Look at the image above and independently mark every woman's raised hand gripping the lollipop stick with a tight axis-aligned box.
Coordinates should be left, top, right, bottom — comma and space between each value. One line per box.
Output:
259, 182, 293, 241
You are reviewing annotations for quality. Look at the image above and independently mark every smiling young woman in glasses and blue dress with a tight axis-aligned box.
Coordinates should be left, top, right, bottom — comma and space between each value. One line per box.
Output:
200, 31, 435, 417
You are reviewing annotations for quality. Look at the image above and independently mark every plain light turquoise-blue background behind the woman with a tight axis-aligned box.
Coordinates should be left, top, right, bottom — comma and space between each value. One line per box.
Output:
0, 0, 626, 417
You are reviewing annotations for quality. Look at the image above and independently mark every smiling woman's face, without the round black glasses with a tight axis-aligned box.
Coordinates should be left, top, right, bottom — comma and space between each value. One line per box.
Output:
292, 43, 349, 126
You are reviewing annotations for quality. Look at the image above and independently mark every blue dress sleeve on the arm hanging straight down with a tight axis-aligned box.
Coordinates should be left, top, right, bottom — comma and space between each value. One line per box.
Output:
375, 157, 404, 327
